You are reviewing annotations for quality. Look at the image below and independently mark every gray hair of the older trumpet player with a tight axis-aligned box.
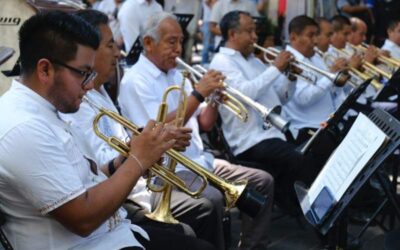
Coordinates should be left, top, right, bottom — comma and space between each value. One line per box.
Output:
140, 11, 177, 44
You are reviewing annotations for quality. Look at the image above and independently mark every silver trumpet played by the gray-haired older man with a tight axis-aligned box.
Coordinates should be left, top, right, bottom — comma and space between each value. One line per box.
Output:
176, 57, 290, 133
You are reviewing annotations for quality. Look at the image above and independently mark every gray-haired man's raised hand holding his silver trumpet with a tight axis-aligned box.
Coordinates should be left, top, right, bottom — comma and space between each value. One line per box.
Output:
196, 70, 225, 97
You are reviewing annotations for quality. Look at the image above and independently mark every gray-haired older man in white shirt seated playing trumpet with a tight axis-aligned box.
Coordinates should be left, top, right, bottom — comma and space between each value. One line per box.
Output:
118, 12, 273, 249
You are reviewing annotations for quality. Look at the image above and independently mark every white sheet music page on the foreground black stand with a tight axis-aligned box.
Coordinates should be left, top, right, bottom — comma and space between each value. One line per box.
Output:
308, 113, 387, 204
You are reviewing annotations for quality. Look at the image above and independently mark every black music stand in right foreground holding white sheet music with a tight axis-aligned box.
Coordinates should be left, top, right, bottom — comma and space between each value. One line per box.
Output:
295, 109, 400, 249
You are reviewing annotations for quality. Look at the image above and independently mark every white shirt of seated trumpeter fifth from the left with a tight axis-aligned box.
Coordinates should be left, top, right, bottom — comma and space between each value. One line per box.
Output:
285, 46, 335, 137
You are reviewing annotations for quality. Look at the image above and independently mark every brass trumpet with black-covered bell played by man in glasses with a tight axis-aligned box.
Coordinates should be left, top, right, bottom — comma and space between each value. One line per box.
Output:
83, 96, 267, 217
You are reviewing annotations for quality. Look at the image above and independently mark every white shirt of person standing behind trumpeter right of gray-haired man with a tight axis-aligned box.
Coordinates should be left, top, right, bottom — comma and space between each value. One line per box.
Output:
210, 0, 260, 46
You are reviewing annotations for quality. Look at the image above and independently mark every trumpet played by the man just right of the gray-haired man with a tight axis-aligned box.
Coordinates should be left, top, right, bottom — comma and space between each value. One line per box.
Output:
254, 44, 350, 86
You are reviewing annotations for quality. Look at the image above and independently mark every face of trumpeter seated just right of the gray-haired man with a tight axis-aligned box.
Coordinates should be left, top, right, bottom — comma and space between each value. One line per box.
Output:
229, 14, 257, 57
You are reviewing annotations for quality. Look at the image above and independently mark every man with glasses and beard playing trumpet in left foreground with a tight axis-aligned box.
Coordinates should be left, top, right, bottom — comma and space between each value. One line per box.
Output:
0, 11, 212, 249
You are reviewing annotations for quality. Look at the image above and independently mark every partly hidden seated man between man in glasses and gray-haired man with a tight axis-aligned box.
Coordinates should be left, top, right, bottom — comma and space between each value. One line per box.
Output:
61, 10, 217, 248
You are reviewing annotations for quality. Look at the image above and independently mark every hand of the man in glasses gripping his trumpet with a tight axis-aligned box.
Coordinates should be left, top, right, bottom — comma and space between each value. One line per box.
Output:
130, 120, 176, 171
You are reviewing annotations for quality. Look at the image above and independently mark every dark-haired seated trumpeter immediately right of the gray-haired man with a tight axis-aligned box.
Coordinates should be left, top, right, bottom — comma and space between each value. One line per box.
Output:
206, 11, 322, 212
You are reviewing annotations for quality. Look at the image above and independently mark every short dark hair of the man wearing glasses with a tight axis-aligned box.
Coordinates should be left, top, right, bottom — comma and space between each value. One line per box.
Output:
19, 11, 100, 74
